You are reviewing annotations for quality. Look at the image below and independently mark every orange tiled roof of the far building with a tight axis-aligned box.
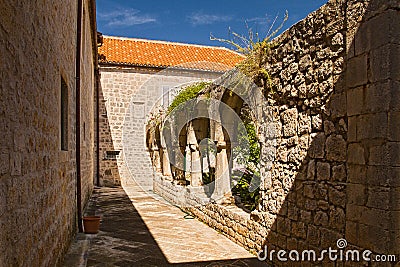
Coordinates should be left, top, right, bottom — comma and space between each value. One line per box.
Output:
99, 36, 244, 71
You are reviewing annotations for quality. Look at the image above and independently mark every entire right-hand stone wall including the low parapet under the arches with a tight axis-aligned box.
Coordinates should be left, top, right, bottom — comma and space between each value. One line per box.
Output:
150, 0, 400, 266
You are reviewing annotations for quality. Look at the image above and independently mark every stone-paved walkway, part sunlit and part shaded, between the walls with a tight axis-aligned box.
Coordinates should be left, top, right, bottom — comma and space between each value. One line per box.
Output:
64, 185, 265, 266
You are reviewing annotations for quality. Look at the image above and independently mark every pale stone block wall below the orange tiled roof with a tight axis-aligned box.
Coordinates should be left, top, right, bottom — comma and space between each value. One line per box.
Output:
100, 65, 220, 189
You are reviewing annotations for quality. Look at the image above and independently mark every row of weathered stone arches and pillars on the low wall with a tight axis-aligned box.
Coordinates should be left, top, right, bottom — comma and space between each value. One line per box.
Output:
146, 70, 264, 203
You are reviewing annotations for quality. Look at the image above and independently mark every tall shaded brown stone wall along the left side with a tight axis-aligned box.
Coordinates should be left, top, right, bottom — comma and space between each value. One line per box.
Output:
0, 1, 93, 266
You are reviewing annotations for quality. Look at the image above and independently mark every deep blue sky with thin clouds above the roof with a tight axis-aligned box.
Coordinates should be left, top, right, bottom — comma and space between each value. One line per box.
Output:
97, 0, 327, 46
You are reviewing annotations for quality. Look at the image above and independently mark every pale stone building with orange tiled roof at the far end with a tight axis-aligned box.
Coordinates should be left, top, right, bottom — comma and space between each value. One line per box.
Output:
99, 36, 243, 188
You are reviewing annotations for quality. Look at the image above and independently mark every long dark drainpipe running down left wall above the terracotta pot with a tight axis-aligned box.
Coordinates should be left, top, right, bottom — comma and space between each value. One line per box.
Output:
75, 0, 83, 233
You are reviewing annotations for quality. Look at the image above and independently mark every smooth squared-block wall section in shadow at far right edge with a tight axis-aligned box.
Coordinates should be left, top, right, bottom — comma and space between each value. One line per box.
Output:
345, 1, 400, 260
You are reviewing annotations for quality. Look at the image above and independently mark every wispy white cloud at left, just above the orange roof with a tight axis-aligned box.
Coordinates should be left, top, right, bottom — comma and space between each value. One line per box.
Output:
98, 8, 157, 26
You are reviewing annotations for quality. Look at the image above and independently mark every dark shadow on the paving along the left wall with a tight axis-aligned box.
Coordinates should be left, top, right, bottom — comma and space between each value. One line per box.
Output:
87, 187, 265, 266
